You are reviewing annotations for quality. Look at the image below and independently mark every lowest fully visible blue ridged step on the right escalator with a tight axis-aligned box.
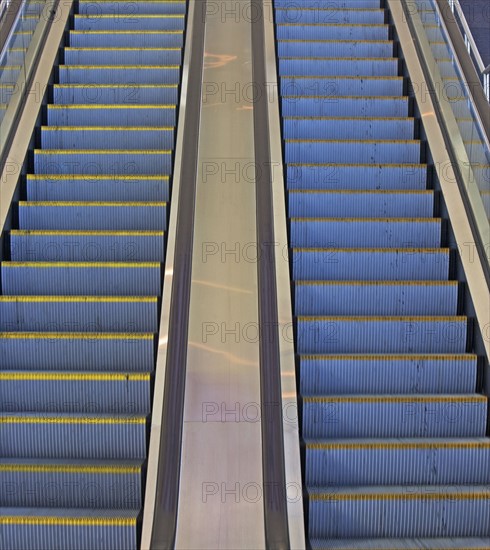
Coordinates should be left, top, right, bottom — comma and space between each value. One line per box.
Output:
309, 485, 490, 548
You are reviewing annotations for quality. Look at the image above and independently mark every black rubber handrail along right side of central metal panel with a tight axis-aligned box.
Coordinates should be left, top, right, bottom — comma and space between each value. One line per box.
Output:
252, 0, 290, 550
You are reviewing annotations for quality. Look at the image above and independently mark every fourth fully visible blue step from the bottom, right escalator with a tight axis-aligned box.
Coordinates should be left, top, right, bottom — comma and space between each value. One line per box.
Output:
299, 354, 477, 396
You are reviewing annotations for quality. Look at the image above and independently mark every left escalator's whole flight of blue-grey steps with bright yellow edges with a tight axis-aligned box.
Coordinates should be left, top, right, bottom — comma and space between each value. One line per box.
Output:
0, 0, 186, 550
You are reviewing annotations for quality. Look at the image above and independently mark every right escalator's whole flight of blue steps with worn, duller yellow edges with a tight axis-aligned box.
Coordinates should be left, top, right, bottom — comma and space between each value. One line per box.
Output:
274, 0, 490, 549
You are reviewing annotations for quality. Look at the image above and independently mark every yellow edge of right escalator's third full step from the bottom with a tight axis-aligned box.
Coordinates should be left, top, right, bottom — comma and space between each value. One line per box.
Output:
303, 394, 487, 403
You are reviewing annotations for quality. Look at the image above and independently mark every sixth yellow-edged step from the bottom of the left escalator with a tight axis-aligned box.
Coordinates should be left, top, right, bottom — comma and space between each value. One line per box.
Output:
0, 295, 158, 332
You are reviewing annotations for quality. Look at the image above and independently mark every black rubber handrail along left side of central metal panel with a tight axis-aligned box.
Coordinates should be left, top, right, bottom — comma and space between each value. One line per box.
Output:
151, 0, 207, 550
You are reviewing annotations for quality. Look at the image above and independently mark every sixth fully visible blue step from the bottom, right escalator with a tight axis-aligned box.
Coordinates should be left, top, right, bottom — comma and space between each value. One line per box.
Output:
294, 281, 459, 316
